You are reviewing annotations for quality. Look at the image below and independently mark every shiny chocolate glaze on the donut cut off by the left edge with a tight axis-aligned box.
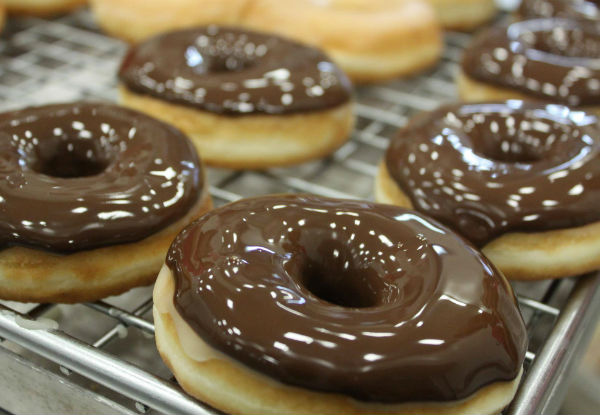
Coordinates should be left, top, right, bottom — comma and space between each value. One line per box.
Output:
0, 103, 203, 252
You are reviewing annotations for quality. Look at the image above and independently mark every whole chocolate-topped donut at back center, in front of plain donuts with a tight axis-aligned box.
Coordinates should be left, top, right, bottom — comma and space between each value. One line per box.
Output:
119, 26, 354, 168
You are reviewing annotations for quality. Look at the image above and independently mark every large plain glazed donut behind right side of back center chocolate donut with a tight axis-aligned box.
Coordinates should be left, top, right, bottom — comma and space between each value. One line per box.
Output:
243, 0, 442, 82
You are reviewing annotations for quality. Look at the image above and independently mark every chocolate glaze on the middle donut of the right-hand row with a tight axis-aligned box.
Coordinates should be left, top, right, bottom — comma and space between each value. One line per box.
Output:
385, 100, 600, 245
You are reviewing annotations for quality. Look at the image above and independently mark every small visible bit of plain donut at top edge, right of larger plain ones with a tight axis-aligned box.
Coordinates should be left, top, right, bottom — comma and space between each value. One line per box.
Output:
428, 0, 498, 30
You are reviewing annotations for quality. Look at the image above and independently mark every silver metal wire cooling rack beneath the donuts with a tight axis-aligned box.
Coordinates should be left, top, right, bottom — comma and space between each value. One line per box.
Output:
0, 10, 600, 414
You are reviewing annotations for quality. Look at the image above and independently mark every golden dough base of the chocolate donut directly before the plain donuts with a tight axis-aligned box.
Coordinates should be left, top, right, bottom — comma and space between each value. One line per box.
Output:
120, 87, 354, 169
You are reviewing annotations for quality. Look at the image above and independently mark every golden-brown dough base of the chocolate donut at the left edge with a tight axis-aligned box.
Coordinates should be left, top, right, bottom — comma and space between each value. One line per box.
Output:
0, 190, 212, 303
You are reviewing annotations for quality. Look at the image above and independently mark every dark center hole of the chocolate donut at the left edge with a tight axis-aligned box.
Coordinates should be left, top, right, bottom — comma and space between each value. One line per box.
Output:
29, 139, 110, 179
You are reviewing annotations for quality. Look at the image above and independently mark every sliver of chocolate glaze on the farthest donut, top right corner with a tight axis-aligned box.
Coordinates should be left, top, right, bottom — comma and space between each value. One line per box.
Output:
519, 0, 600, 21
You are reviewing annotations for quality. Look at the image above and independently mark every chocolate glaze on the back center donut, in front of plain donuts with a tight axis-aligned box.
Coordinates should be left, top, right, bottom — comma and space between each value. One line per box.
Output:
119, 26, 351, 115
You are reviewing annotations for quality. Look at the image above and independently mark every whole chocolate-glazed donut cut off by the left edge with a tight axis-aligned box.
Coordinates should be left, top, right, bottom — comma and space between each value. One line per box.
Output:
0, 103, 211, 303
